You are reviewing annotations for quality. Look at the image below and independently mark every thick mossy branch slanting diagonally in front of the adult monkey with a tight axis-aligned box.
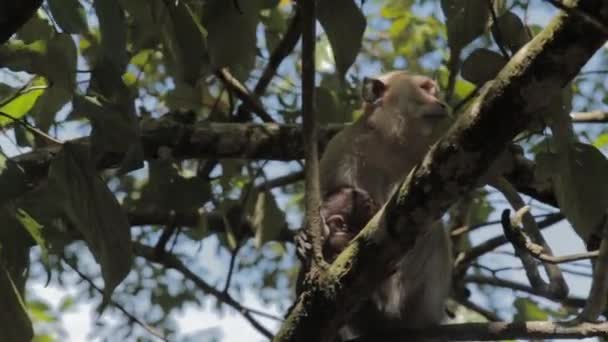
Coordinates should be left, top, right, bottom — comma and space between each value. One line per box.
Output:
275, 0, 608, 341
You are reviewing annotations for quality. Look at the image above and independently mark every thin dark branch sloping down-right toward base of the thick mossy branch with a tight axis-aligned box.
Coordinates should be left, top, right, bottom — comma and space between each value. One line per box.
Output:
133, 242, 272, 339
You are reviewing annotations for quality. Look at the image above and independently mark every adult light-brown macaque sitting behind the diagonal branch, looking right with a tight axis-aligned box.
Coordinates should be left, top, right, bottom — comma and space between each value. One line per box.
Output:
297, 71, 452, 339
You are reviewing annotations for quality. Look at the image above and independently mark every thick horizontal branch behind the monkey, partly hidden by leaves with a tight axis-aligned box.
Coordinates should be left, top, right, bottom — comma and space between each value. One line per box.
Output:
13, 120, 557, 207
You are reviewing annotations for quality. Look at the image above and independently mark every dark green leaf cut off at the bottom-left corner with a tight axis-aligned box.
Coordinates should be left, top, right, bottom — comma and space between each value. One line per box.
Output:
0, 268, 34, 341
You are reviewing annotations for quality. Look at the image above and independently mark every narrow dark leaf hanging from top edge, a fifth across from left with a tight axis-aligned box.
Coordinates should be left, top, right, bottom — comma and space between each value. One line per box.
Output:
94, 0, 129, 69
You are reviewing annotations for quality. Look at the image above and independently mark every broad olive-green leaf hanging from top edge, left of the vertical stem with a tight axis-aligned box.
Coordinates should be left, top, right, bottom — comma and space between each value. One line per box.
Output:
203, 0, 261, 78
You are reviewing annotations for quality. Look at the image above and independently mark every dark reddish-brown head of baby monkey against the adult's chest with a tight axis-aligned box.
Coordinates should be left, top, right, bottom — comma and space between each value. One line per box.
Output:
321, 187, 377, 261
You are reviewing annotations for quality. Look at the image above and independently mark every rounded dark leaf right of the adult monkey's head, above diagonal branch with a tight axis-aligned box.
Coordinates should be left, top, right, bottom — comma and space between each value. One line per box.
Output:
462, 49, 507, 86
